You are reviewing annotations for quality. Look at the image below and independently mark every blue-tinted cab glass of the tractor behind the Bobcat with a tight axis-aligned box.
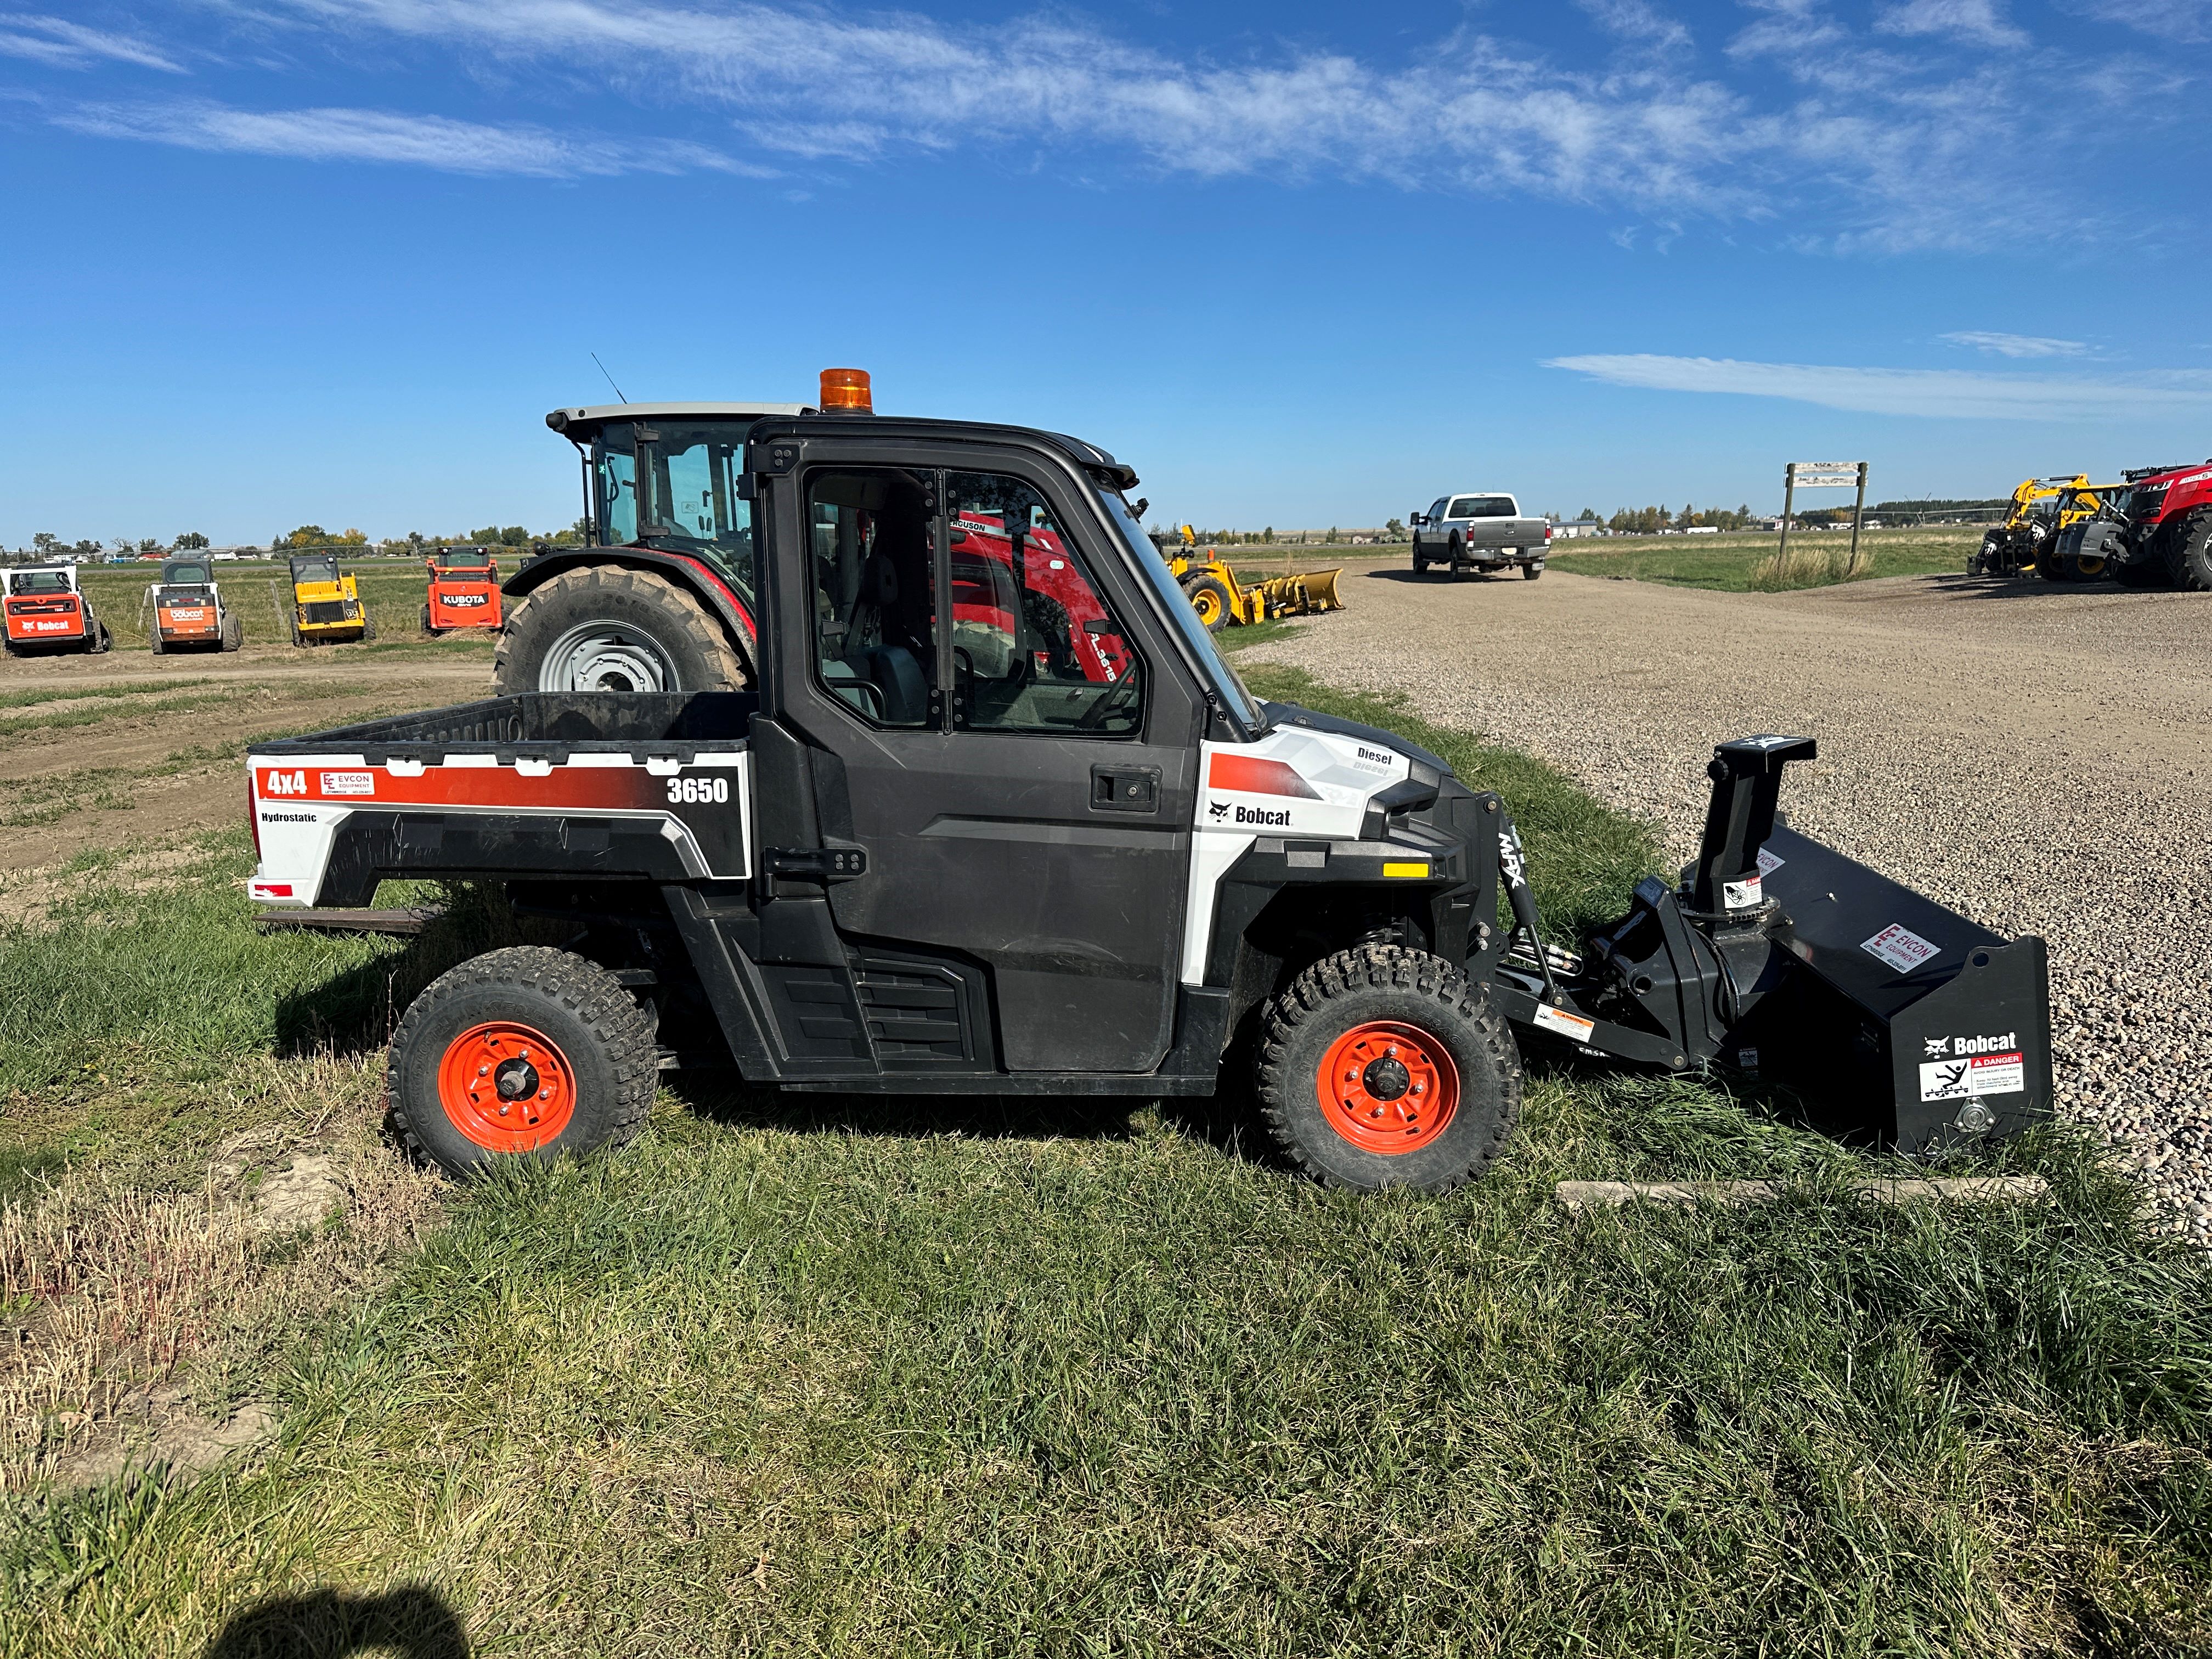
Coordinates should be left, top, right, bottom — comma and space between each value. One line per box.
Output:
591, 420, 754, 606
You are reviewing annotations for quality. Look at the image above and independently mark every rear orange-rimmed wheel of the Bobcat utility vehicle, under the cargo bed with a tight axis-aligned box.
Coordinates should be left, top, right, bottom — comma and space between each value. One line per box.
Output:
385, 945, 659, 1177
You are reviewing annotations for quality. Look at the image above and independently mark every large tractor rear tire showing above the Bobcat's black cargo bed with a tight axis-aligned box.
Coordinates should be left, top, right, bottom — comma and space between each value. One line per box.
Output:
491, 564, 752, 697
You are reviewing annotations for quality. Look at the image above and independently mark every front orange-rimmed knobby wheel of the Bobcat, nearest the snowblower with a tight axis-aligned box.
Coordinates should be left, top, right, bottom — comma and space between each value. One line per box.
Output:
1256, 945, 1522, 1192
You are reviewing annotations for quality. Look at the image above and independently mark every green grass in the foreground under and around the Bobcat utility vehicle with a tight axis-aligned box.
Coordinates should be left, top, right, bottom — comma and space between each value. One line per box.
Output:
0, 668, 2212, 1657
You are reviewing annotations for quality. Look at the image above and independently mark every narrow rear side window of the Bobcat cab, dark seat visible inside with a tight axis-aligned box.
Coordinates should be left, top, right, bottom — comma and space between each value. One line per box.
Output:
805, 467, 938, 730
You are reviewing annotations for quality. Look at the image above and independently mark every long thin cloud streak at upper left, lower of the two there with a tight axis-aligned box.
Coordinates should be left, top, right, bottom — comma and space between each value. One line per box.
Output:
53, 101, 774, 179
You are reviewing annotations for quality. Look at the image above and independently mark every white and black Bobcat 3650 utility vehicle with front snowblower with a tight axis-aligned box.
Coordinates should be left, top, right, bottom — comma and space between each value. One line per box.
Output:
248, 376, 2051, 1192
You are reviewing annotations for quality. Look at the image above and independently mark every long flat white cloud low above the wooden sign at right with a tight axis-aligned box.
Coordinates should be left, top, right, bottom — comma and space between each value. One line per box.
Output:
1544, 352, 2212, 420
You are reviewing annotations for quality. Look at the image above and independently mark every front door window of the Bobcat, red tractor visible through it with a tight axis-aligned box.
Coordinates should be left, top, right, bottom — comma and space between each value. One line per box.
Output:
945, 473, 1144, 737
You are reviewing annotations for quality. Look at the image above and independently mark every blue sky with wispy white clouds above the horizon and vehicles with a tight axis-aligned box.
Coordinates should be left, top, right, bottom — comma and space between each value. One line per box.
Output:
0, 0, 2212, 546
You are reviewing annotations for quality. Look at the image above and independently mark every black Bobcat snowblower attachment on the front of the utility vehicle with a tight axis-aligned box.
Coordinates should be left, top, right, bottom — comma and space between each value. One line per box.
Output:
1493, 737, 2051, 1153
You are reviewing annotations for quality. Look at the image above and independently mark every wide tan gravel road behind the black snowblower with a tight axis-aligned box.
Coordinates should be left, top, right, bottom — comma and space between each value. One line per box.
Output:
1250, 566, 2212, 1243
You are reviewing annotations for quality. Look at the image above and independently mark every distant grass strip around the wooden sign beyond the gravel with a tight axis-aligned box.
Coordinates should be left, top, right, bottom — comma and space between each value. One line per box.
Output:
1548, 524, 1982, 593
